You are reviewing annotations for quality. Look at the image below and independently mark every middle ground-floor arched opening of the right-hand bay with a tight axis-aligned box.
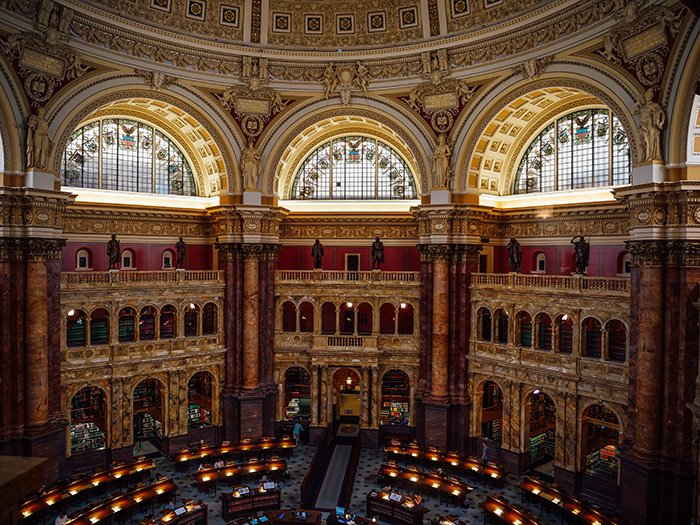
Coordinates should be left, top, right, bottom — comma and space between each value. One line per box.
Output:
525, 390, 557, 472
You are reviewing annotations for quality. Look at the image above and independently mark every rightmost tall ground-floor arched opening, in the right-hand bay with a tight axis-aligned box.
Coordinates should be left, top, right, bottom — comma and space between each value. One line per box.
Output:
581, 404, 622, 476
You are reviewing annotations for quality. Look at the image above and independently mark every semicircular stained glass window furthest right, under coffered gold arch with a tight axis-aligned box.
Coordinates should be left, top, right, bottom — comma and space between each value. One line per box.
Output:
515, 109, 630, 193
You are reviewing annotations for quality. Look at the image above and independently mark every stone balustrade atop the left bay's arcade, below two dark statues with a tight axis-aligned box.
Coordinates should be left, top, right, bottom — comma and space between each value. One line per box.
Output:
61, 270, 224, 288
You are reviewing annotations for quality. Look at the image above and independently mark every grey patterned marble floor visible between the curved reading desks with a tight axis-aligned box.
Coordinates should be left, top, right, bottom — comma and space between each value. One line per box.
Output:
45, 445, 612, 525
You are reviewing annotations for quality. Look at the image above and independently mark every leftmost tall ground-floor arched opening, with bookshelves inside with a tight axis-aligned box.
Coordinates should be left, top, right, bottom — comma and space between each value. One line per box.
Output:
70, 386, 107, 454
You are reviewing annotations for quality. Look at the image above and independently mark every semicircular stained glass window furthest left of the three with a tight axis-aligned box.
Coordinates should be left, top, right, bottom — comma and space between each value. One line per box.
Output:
61, 119, 197, 195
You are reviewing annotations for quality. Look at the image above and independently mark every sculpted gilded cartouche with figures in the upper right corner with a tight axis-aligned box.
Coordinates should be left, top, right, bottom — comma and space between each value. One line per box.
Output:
598, 1, 685, 86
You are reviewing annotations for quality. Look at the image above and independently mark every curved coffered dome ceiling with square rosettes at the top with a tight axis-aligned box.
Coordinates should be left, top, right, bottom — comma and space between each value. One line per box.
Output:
78, 0, 552, 51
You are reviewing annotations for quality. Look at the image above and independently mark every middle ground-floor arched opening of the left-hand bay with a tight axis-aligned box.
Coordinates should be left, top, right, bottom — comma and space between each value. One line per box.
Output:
133, 379, 164, 455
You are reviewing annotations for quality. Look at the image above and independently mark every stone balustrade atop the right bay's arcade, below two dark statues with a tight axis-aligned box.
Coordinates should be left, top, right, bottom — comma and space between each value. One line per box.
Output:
471, 273, 630, 295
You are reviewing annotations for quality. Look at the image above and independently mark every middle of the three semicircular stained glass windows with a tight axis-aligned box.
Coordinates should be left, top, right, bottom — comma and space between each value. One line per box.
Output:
292, 136, 417, 200
